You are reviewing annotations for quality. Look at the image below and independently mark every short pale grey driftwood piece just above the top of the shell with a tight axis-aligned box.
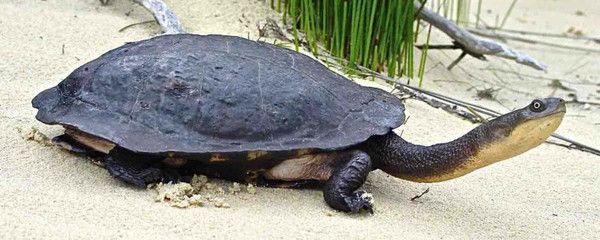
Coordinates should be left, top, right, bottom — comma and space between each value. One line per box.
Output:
134, 0, 185, 34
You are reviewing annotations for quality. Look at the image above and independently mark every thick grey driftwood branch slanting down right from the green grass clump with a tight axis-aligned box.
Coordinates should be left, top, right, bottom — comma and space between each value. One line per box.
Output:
414, 1, 547, 71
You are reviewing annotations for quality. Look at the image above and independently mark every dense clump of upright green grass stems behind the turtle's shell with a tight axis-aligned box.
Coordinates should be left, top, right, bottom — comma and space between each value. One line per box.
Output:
271, 0, 422, 78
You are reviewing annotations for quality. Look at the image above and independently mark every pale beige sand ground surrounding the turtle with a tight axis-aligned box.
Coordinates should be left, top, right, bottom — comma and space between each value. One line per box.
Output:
0, 0, 600, 239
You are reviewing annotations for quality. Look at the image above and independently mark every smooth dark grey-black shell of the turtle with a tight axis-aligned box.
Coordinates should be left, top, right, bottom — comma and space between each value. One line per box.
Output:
32, 34, 404, 153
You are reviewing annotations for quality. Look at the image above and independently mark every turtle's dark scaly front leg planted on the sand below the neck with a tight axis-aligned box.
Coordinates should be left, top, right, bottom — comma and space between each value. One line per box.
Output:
323, 151, 373, 213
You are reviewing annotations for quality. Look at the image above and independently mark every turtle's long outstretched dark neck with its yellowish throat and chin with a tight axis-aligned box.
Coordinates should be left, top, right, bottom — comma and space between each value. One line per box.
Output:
360, 109, 564, 182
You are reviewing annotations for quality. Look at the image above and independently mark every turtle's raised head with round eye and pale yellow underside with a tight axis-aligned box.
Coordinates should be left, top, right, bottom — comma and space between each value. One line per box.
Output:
476, 98, 566, 163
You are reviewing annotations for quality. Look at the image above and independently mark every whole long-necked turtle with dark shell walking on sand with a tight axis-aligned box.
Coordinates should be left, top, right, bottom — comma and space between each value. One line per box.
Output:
32, 34, 566, 213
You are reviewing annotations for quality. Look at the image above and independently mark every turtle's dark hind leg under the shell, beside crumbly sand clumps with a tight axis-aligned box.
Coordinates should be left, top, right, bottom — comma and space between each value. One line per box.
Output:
104, 148, 180, 187
